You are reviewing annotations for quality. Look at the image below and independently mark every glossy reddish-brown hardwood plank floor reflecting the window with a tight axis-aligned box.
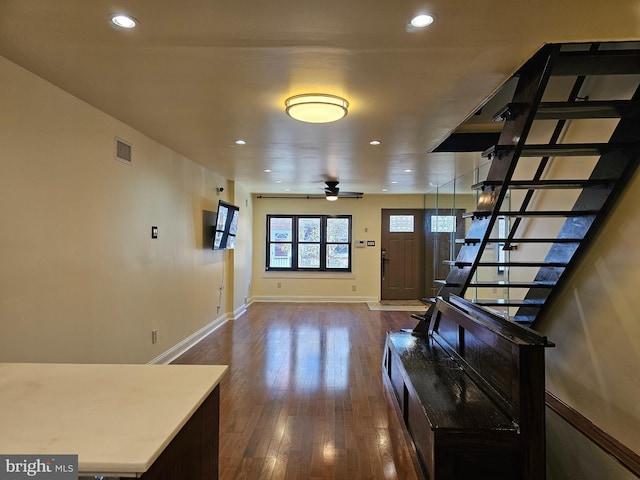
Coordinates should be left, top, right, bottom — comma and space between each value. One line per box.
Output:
173, 303, 421, 480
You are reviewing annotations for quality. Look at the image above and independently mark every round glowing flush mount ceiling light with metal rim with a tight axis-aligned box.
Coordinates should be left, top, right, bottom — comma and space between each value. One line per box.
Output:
284, 93, 349, 123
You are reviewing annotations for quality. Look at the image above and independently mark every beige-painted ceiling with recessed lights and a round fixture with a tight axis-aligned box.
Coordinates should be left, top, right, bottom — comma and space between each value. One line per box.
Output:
0, 0, 640, 194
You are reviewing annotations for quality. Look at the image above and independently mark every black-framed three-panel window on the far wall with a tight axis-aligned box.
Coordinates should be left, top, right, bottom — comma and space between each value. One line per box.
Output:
265, 215, 351, 272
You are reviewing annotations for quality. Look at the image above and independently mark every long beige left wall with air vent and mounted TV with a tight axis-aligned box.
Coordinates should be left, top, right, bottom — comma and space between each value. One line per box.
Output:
0, 57, 238, 363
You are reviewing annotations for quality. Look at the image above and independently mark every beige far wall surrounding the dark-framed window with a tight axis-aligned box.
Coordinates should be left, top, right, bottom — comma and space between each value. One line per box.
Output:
251, 195, 424, 301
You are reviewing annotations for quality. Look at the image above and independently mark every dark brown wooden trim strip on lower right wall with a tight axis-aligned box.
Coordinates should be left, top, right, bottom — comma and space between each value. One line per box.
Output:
545, 391, 640, 477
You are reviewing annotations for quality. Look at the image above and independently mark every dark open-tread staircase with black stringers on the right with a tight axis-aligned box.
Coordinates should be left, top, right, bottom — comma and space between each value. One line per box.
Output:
414, 43, 640, 333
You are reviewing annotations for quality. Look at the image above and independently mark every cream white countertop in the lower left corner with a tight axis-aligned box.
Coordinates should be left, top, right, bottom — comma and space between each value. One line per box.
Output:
0, 363, 228, 477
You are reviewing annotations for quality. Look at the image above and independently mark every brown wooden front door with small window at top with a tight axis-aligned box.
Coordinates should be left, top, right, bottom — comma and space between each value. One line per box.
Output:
380, 209, 424, 300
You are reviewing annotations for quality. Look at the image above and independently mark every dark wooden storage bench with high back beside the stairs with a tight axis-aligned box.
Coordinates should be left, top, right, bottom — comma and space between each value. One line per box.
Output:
383, 297, 552, 480
